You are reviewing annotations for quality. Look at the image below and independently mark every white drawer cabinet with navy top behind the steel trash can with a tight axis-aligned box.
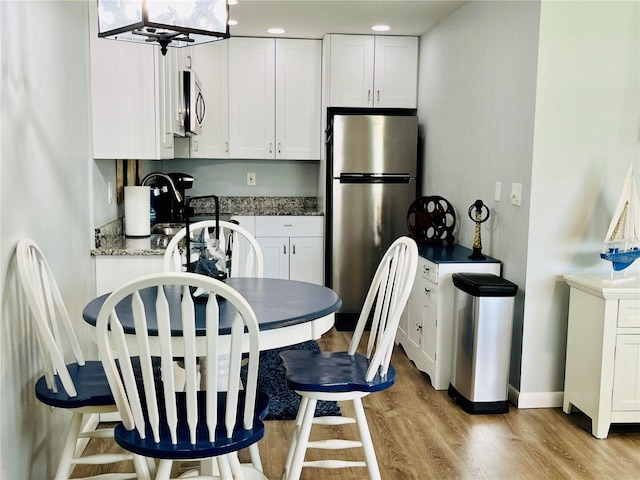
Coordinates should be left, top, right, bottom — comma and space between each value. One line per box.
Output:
396, 245, 501, 390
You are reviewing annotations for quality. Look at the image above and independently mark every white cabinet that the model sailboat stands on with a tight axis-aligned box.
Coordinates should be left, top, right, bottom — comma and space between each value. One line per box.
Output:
563, 275, 640, 438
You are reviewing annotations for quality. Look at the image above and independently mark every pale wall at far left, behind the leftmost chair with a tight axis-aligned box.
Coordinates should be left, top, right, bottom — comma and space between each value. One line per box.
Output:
0, 1, 94, 479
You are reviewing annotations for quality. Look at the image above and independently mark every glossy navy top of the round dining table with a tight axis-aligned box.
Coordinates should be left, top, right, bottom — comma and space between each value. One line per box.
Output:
82, 277, 342, 335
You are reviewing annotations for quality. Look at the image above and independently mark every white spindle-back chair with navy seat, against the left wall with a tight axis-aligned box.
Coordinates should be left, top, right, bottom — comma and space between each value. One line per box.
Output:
16, 239, 146, 480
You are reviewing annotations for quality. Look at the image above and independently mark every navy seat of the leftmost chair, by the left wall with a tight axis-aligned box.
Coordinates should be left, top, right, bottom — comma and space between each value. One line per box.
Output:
36, 360, 114, 408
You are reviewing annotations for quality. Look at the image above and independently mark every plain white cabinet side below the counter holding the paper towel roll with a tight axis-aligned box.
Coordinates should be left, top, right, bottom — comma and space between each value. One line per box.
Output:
94, 255, 164, 295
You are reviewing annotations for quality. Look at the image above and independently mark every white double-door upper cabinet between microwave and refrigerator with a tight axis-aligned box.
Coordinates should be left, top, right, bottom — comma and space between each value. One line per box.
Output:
229, 38, 322, 160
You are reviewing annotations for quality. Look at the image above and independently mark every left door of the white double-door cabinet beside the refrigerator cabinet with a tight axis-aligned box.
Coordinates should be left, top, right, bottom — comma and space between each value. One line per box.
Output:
228, 37, 275, 159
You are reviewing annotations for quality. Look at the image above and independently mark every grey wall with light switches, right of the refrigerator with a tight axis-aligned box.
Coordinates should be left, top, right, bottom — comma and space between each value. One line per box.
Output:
418, 2, 539, 394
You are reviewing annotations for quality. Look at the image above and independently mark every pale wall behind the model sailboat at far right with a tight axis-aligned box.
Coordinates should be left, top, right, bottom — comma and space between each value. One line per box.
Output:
520, 1, 640, 403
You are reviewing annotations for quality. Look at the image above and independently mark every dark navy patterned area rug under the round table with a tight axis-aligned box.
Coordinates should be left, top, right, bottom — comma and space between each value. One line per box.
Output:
243, 340, 341, 420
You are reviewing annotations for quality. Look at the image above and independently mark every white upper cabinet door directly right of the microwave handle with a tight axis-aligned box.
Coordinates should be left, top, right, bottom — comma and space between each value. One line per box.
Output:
191, 40, 229, 158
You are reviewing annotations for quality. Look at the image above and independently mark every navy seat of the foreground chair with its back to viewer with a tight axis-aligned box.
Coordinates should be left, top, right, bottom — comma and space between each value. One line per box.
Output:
114, 392, 269, 460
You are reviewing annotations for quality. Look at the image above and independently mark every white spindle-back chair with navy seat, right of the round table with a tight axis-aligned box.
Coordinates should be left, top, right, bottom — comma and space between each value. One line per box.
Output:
280, 237, 418, 480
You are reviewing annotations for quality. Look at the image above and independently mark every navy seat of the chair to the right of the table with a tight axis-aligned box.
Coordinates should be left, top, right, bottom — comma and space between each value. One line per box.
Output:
280, 350, 396, 392
